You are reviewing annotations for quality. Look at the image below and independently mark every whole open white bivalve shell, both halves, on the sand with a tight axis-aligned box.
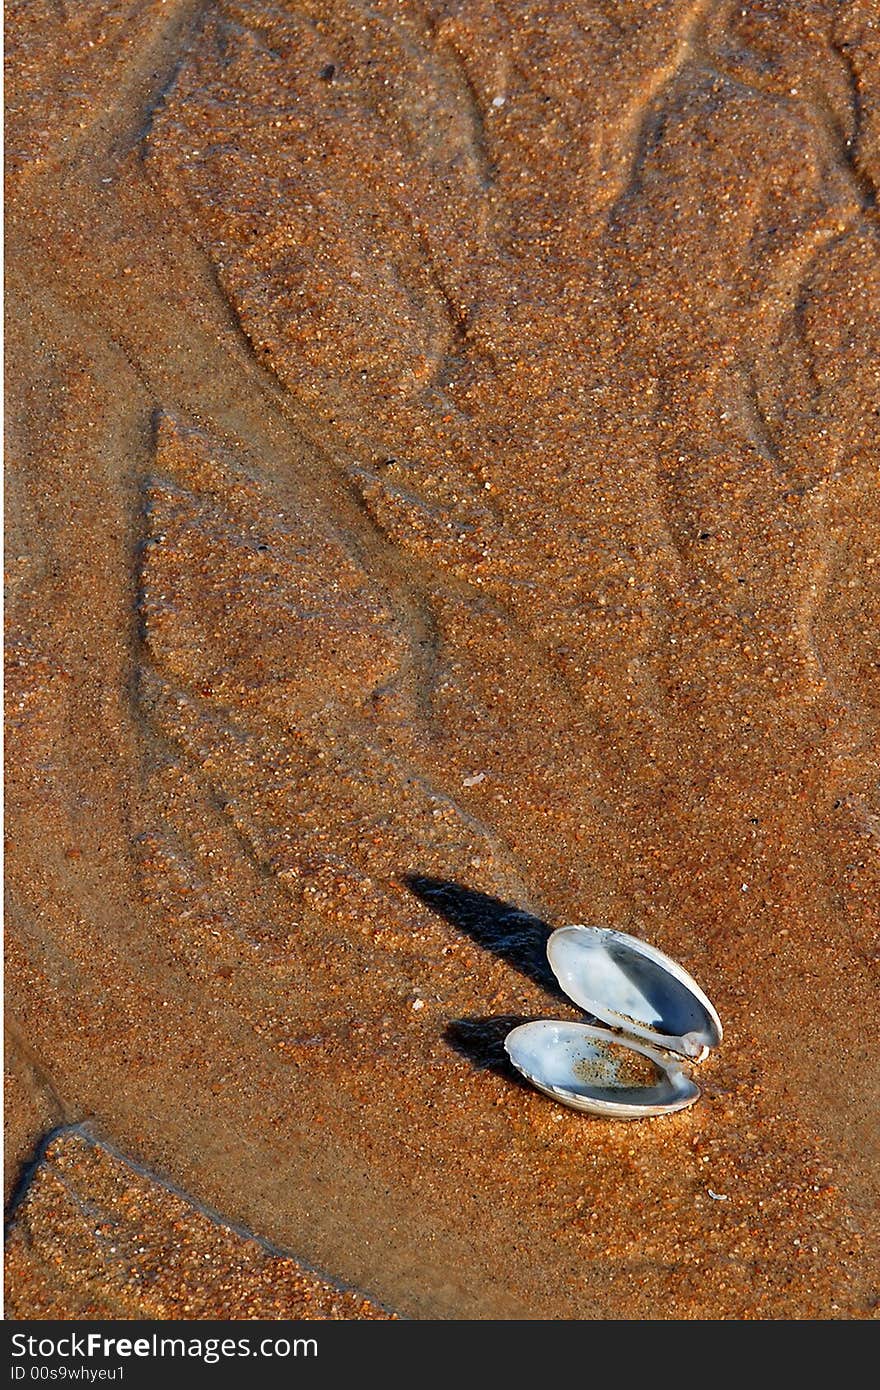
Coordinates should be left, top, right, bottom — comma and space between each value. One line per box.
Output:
505, 926, 722, 1119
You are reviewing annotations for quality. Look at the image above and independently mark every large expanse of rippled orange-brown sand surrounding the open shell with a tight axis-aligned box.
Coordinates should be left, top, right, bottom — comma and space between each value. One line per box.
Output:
7, 0, 880, 1319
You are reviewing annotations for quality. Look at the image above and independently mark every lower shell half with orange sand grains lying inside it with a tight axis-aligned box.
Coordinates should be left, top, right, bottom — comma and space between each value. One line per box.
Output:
505, 1019, 699, 1120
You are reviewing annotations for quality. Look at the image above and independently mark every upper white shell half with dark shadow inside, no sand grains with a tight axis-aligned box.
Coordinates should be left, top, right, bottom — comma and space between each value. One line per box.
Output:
546, 926, 722, 1062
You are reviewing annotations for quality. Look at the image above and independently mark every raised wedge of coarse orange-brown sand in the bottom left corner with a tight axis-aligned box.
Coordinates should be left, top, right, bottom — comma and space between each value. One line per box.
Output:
6, 1130, 388, 1319
